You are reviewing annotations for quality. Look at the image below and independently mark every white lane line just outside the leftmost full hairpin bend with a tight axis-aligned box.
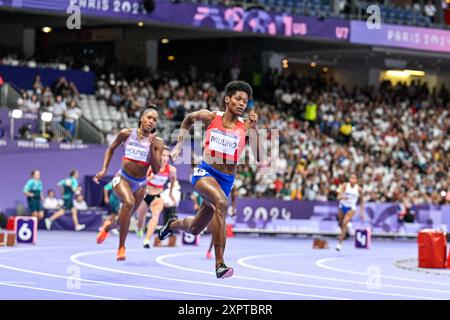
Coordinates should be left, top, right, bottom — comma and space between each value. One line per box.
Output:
0, 247, 243, 300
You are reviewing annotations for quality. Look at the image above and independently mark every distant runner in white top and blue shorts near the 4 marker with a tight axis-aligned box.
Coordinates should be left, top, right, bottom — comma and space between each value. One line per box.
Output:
336, 173, 364, 251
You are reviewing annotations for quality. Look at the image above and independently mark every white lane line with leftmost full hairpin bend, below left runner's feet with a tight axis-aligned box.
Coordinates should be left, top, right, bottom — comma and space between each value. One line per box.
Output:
70, 249, 342, 299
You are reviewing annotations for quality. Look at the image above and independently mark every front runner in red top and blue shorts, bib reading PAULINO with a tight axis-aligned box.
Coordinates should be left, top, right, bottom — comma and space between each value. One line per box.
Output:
159, 81, 262, 279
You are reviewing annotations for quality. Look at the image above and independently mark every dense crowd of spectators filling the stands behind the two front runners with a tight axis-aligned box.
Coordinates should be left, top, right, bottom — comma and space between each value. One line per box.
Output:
89, 70, 450, 203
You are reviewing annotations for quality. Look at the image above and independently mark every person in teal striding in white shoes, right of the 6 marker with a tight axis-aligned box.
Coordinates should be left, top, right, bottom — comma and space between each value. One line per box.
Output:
45, 170, 86, 231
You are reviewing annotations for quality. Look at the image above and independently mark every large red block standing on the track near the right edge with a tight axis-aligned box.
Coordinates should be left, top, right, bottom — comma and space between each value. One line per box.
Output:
417, 229, 447, 268
